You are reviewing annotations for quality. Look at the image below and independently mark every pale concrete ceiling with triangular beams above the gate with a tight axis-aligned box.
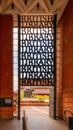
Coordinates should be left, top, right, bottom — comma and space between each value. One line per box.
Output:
0, 0, 69, 21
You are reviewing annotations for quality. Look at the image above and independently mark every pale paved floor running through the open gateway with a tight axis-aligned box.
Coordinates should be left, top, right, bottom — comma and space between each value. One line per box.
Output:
0, 106, 69, 130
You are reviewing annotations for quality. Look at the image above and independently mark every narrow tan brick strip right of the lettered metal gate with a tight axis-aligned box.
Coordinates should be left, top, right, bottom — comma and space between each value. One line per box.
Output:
56, 24, 61, 117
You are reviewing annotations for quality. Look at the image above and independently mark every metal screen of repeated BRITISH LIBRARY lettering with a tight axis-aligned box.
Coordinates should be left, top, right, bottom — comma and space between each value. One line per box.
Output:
19, 15, 56, 86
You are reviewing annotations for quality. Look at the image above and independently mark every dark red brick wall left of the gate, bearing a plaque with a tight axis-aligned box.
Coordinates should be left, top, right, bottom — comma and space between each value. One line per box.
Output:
0, 15, 13, 119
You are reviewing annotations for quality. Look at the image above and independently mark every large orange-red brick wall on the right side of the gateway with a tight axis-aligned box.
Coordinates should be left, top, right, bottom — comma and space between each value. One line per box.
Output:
60, 0, 73, 117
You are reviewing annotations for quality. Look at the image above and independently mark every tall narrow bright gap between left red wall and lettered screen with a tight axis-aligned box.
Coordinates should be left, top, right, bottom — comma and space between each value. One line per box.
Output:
13, 28, 18, 90
